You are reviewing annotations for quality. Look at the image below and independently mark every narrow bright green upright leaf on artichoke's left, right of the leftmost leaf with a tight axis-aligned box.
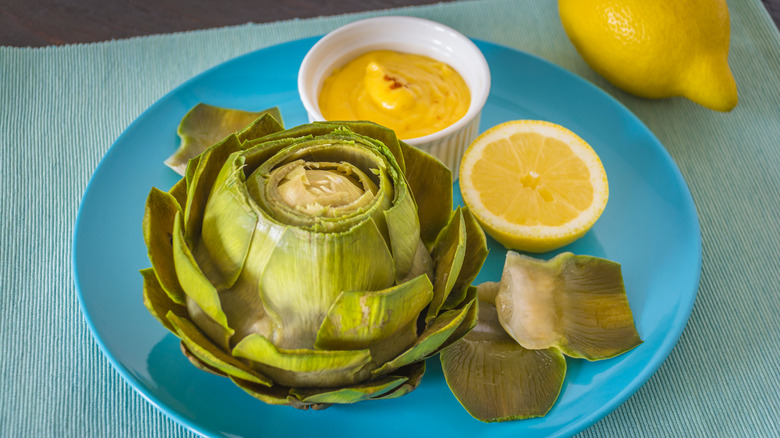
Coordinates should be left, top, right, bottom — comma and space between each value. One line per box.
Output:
173, 212, 232, 334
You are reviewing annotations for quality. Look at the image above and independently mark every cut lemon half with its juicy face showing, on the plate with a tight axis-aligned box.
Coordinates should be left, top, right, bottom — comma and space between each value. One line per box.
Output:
460, 120, 609, 252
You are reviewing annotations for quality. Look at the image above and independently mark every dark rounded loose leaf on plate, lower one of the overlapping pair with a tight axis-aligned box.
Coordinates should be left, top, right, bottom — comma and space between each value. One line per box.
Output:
440, 301, 566, 422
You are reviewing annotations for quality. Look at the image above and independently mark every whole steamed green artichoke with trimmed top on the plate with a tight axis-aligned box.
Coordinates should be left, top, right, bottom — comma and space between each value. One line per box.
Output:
137, 108, 487, 408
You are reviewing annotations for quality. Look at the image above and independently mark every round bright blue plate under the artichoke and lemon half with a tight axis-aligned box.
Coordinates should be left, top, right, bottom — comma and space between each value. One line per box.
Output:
73, 38, 701, 437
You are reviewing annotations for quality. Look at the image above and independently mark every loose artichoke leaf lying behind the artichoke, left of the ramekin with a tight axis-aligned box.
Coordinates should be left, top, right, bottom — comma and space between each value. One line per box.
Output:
165, 103, 282, 176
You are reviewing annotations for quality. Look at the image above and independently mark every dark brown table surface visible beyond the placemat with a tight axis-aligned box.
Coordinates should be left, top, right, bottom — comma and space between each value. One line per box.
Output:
0, 0, 780, 47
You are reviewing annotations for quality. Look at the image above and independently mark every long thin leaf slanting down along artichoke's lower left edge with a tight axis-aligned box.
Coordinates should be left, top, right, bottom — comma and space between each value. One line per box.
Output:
166, 312, 273, 386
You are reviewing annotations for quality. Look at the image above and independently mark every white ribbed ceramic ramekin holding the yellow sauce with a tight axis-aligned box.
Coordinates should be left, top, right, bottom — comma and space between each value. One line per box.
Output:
298, 16, 490, 180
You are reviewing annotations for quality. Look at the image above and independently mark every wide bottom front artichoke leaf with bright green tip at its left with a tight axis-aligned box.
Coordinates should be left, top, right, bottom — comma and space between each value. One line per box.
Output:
233, 334, 371, 388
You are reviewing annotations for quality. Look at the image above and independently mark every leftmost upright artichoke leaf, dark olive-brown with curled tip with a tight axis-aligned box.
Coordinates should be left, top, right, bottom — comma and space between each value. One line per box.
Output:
143, 188, 185, 305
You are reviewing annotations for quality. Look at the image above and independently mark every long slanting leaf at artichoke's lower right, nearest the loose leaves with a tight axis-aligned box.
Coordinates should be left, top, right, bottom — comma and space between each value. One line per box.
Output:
372, 290, 477, 376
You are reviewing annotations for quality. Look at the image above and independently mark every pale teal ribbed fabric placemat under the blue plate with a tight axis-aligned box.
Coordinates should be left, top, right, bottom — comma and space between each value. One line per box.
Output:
0, 0, 780, 437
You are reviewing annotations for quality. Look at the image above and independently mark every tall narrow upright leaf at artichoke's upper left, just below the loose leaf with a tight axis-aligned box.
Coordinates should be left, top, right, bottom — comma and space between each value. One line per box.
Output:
184, 135, 241, 242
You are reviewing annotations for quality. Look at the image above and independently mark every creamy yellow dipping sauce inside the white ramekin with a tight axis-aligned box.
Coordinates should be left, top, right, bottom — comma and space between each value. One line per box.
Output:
319, 50, 471, 140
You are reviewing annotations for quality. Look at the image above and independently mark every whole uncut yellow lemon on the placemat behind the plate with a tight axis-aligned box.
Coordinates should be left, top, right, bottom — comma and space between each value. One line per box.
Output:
558, 0, 737, 111
